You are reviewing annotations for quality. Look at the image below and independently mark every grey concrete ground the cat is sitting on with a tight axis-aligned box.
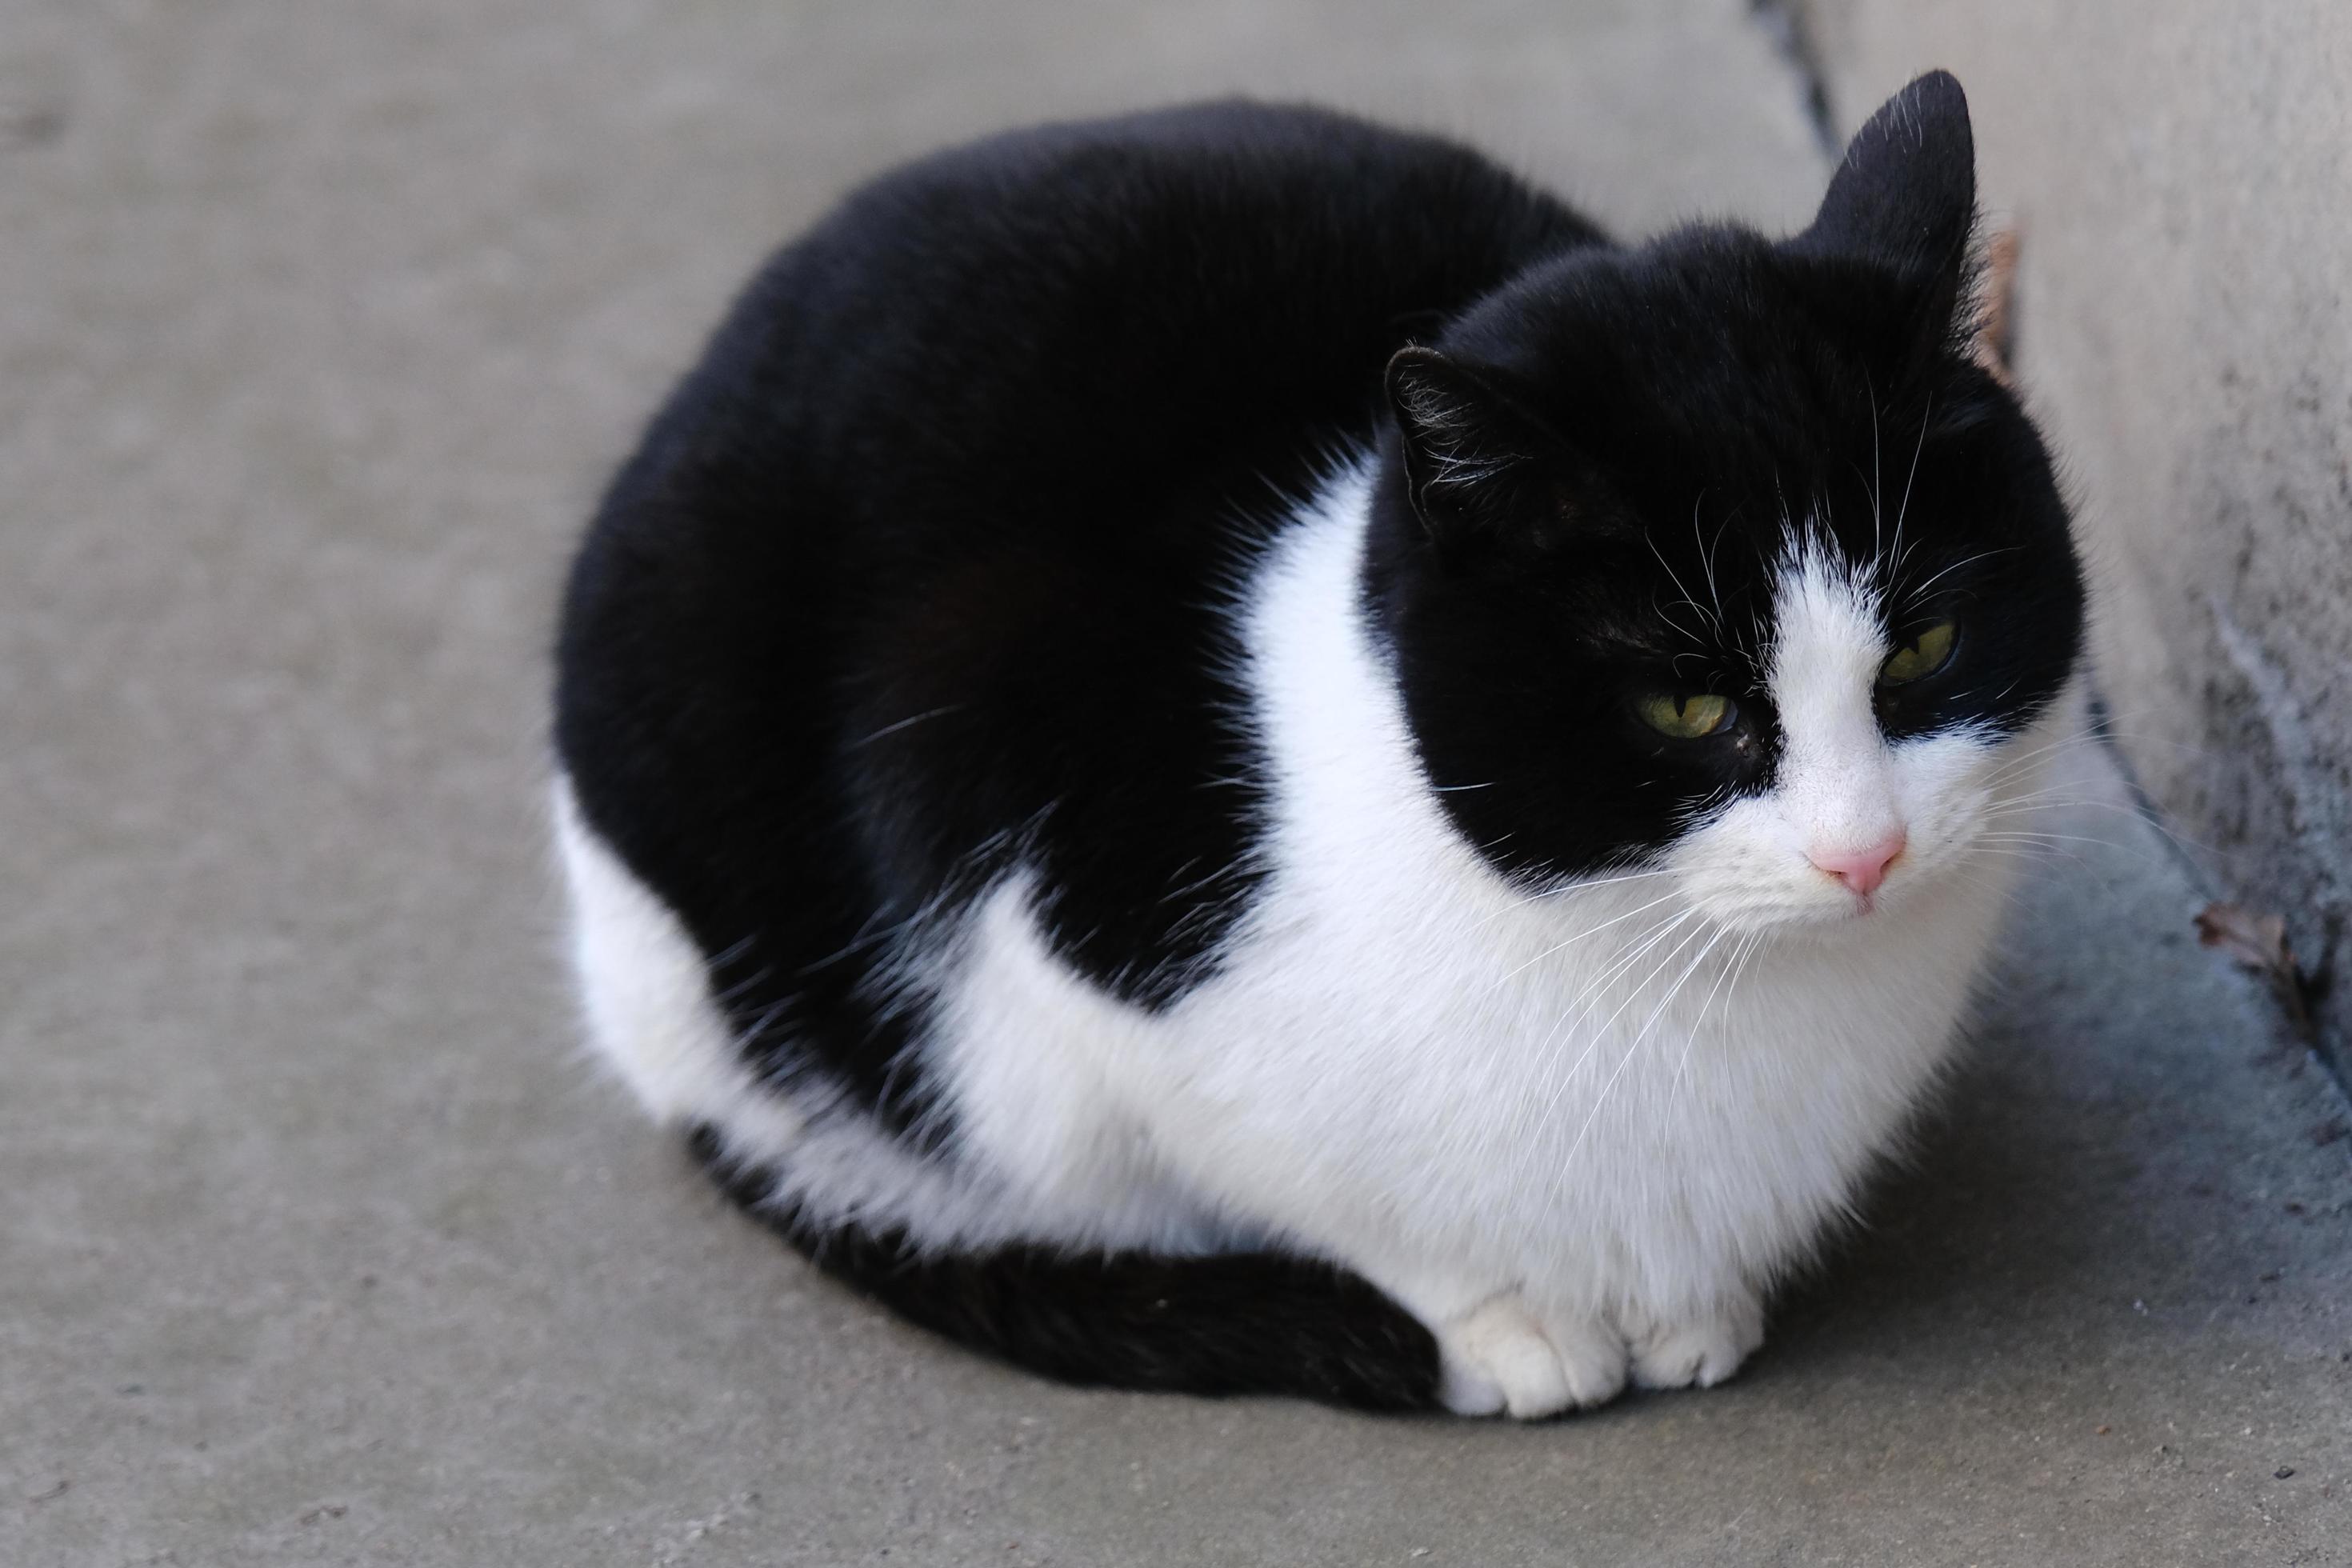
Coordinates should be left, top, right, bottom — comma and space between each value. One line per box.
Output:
0, 0, 2352, 1566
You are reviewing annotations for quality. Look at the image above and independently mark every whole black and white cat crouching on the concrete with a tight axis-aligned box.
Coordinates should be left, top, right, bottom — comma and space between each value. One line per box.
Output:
555, 73, 2082, 1415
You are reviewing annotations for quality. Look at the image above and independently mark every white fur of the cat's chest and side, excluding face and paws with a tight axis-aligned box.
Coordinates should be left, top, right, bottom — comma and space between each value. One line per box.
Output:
938, 470, 2002, 1300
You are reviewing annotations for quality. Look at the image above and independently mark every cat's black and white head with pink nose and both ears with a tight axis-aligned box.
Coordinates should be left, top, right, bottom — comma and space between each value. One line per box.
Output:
1364, 73, 2082, 929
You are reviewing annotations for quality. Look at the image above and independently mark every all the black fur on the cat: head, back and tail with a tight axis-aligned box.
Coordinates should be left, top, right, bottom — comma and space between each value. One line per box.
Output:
558, 75, 2082, 1408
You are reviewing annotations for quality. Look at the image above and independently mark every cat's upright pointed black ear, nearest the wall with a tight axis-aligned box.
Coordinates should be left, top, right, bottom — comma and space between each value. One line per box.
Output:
1785, 70, 1976, 338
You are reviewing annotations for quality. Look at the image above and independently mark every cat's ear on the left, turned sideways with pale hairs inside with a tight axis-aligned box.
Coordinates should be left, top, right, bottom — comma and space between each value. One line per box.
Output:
1388, 348, 1557, 543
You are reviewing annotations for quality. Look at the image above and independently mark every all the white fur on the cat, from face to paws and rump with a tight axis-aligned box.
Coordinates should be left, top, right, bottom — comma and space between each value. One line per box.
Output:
558, 460, 2049, 1415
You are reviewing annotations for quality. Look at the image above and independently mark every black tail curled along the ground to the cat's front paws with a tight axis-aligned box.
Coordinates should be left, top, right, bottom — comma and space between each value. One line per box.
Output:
694, 1128, 1437, 1410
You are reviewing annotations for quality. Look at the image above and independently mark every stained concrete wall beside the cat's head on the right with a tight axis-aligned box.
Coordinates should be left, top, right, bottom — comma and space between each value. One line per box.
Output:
1797, 0, 2352, 1086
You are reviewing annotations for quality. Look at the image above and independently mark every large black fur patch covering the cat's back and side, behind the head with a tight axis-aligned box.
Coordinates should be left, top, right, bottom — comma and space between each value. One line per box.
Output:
558, 103, 1599, 1128
